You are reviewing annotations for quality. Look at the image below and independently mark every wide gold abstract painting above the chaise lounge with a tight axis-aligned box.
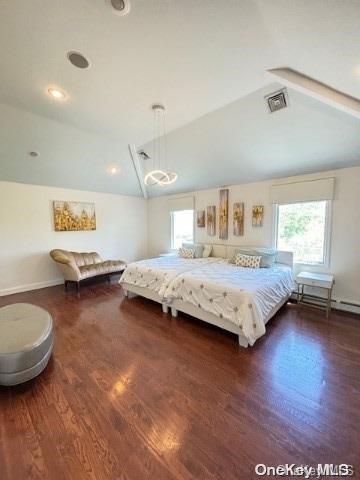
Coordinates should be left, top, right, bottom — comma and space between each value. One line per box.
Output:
53, 201, 96, 232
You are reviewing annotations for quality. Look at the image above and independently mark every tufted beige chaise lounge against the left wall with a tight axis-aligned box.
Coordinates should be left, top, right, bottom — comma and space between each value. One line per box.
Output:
50, 249, 126, 293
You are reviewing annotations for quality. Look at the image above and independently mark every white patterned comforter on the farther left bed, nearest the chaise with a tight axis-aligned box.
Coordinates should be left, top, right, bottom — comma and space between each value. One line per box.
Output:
119, 256, 221, 299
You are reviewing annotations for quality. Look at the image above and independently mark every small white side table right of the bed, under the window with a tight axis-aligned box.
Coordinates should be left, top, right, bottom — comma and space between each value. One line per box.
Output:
296, 272, 335, 317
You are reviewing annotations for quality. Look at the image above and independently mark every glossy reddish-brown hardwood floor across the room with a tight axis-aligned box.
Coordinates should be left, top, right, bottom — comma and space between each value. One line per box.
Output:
0, 285, 360, 480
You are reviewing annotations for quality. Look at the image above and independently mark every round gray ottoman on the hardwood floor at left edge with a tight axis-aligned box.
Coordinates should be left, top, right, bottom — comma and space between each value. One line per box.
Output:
0, 303, 54, 385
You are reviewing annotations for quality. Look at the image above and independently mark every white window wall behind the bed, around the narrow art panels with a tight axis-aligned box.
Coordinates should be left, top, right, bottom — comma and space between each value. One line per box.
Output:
148, 167, 360, 304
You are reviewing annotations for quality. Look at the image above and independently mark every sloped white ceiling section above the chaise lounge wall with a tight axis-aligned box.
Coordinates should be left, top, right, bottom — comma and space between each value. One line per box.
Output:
0, 105, 140, 195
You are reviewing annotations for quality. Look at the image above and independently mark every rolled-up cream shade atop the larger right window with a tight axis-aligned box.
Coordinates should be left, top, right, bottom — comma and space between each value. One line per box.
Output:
270, 177, 335, 203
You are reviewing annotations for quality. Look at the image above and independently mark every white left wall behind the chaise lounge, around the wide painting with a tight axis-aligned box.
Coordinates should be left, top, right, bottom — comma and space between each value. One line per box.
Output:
0, 182, 147, 295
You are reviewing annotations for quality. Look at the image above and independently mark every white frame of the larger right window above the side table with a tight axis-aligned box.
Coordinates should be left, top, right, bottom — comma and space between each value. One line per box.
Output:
273, 200, 332, 268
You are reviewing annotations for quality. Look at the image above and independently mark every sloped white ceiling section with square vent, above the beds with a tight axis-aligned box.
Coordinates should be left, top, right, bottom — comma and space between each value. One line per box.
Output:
144, 83, 360, 196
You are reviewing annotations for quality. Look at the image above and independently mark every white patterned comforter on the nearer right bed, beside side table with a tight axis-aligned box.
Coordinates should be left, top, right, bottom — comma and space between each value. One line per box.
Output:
164, 260, 293, 345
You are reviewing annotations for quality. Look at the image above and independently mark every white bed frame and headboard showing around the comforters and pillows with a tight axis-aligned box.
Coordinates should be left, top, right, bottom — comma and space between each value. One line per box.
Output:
122, 249, 293, 348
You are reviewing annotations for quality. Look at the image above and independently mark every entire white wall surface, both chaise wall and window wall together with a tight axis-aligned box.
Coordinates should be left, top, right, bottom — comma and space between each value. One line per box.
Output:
0, 167, 360, 303
